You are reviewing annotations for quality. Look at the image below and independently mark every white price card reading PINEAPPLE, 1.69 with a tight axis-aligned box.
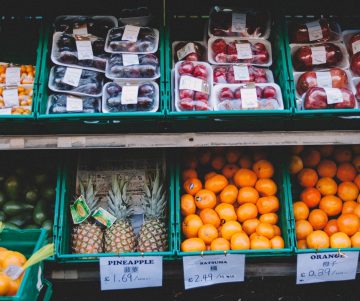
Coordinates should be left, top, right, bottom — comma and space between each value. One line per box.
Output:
100, 256, 163, 291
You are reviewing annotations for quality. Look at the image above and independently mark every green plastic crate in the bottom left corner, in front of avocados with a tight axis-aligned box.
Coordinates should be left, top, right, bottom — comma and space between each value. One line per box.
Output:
0, 229, 46, 301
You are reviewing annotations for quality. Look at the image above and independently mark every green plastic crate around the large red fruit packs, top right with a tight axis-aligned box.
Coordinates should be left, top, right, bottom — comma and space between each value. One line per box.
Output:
282, 15, 360, 119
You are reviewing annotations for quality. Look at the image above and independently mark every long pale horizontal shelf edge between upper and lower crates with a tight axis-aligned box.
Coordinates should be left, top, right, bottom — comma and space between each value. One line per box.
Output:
0, 131, 360, 150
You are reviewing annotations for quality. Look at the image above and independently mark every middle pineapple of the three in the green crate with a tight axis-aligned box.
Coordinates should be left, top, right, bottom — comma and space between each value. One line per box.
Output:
104, 176, 136, 253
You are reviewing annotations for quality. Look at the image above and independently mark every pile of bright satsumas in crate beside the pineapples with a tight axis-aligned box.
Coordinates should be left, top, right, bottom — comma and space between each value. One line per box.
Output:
180, 148, 284, 252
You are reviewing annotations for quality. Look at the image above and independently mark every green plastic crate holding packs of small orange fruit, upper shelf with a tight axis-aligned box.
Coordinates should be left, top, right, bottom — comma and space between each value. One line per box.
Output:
0, 16, 44, 122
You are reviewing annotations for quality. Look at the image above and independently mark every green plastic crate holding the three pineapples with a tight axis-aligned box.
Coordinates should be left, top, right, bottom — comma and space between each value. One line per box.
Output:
56, 151, 175, 263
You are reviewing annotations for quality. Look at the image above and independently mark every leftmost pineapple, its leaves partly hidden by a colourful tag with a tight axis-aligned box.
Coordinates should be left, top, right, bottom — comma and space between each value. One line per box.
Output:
71, 177, 104, 254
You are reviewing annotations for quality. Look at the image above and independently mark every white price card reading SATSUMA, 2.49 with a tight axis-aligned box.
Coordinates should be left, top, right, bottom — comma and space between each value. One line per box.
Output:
183, 254, 245, 289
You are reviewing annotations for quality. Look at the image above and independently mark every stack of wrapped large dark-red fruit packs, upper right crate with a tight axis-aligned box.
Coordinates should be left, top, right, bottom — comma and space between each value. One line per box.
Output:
287, 17, 357, 110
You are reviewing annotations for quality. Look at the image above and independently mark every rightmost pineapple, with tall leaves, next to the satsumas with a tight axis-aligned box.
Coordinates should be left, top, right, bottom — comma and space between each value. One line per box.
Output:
138, 168, 167, 252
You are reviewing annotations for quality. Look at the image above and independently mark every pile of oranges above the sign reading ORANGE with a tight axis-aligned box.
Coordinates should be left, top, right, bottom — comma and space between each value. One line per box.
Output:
290, 145, 360, 249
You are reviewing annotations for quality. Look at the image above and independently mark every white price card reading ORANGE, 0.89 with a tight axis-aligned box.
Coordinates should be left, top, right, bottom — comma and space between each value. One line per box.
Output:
296, 252, 359, 284
